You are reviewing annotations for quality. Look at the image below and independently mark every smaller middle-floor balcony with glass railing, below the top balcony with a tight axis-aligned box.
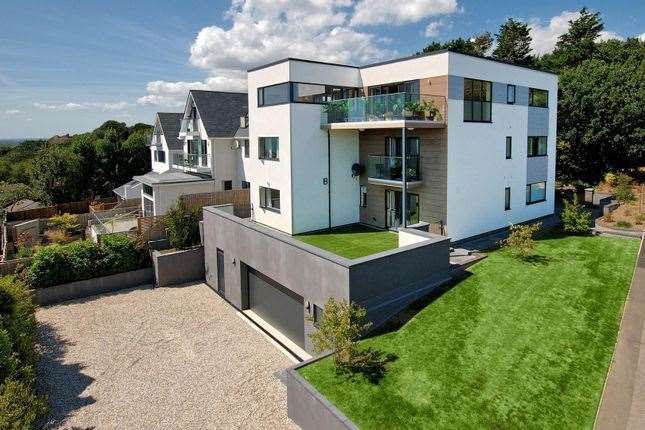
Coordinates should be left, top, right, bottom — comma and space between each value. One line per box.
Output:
367, 155, 422, 188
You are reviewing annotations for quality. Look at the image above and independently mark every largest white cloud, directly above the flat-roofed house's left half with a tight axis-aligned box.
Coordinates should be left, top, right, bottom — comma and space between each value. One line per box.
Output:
138, 0, 400, 107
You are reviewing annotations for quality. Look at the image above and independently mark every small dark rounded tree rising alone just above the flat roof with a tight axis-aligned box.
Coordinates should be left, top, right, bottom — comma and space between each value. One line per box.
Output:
493, 18, 533, 65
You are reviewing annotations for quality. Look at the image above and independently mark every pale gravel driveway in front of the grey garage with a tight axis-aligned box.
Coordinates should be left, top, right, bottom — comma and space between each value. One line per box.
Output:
36, 284, 295, 429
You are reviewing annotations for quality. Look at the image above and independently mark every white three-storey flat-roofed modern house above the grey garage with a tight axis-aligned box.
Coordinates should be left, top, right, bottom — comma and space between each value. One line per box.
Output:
244, 51, 557, 241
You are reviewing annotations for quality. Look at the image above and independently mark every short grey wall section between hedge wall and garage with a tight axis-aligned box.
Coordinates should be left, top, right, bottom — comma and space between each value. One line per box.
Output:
152, 246, 205, 287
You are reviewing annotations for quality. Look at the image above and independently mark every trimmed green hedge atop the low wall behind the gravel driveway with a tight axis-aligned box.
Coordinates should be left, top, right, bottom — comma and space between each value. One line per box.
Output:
25, 235, 144, 288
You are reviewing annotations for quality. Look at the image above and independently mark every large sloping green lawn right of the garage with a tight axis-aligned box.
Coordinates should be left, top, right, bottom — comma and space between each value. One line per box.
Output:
300, 236, 639, 429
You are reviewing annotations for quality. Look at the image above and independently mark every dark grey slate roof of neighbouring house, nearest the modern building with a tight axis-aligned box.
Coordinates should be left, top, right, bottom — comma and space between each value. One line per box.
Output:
190, 90, 249, 137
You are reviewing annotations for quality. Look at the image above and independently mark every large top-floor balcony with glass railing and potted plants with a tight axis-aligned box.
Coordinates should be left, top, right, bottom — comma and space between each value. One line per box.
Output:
321, 93, 446, 130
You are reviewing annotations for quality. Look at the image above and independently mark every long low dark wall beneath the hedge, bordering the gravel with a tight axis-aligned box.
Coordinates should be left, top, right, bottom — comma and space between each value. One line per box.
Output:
32, 267, 154, 306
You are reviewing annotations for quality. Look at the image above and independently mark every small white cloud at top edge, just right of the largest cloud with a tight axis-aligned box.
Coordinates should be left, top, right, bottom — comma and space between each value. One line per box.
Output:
350, 0, 460, 25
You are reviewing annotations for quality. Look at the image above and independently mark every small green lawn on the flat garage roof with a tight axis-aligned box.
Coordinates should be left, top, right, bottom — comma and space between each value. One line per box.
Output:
294, 224, 399, 259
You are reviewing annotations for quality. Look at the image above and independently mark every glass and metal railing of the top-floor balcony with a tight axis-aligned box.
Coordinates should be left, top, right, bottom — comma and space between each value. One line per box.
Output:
322, 93, 446, 124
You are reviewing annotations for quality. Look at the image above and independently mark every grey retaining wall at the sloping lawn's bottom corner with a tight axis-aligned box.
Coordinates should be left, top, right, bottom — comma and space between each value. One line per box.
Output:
286, 358, 358, 430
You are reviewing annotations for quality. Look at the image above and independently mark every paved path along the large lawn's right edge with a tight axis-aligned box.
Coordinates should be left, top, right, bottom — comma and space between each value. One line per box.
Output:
595, 235, 645, 430
